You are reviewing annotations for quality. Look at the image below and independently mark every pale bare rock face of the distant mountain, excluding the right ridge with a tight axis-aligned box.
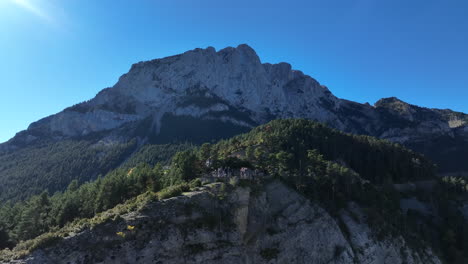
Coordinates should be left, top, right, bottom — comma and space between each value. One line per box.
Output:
9, 45, 345, 142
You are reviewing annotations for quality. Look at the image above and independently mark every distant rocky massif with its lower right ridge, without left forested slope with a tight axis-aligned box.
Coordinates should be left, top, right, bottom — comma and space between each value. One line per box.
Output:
0, 45, 468, 172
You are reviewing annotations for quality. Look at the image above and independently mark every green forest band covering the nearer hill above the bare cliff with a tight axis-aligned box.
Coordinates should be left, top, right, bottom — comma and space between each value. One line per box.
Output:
0, 119, 468, 263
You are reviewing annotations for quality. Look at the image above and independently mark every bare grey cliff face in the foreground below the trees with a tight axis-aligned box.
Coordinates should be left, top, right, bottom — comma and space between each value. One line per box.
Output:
5, 181, 440, 264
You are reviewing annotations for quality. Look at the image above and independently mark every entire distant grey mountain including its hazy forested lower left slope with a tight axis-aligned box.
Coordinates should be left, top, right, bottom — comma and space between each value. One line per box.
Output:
0, 45, 468, 201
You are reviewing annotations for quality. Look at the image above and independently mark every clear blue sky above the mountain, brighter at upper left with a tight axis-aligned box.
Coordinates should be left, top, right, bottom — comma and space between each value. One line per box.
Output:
0, 0, 468, 142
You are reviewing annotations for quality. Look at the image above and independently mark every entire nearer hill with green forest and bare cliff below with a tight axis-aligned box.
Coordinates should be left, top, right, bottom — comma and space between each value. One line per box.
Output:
0, 119, 460, 264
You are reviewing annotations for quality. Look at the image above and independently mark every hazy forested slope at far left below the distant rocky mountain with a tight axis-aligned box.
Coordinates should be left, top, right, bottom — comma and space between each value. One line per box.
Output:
0, 138, 136, 203
